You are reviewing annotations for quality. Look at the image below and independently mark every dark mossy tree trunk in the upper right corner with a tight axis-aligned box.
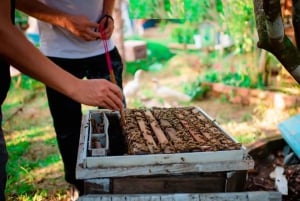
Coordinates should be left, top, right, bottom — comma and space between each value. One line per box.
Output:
253, 0, 300, 84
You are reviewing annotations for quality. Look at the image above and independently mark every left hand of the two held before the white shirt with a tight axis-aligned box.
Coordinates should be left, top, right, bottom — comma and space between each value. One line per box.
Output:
63, 15, 100, 41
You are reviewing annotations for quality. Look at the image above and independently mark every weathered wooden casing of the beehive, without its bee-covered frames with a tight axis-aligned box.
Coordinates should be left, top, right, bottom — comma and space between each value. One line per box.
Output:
76, 108, 254, 194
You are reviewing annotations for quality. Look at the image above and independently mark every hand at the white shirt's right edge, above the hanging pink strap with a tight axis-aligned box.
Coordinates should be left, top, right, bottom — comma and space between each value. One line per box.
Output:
99, 15, 114, 40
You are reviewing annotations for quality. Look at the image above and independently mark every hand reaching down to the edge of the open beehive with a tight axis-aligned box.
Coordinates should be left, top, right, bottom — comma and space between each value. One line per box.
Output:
71, 79, 123, 111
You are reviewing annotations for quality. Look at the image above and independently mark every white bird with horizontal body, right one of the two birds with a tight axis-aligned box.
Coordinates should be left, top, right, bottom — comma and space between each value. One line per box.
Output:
152, 79, 192, 106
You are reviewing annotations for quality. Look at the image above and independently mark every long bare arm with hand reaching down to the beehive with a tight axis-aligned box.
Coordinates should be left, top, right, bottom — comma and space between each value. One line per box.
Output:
0, 0, 122, 110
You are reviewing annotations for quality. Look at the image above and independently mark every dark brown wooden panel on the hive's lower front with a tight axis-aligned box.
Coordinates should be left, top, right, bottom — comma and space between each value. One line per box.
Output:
110, 173, 226, 194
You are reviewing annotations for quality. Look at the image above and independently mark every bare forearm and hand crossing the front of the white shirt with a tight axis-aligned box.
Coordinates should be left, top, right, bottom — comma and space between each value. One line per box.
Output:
16, 0, 99, 41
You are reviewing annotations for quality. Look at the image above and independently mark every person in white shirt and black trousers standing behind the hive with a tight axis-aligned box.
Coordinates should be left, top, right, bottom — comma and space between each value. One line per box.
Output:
17, 0, 126, 195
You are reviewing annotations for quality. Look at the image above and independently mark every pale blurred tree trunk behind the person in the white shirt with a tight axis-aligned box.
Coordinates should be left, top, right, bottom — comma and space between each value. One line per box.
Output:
112, 0, 126, 72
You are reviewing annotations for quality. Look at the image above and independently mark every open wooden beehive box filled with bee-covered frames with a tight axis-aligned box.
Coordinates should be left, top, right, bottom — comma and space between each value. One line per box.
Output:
76, 107, 254, 194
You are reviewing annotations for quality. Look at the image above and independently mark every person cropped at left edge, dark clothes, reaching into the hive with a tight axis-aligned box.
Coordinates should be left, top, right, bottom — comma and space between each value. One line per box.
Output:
0, 0, 123, 201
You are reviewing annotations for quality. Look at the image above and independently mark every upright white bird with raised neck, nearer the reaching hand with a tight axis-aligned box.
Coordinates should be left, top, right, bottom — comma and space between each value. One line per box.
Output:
123, 69, 144, 103
